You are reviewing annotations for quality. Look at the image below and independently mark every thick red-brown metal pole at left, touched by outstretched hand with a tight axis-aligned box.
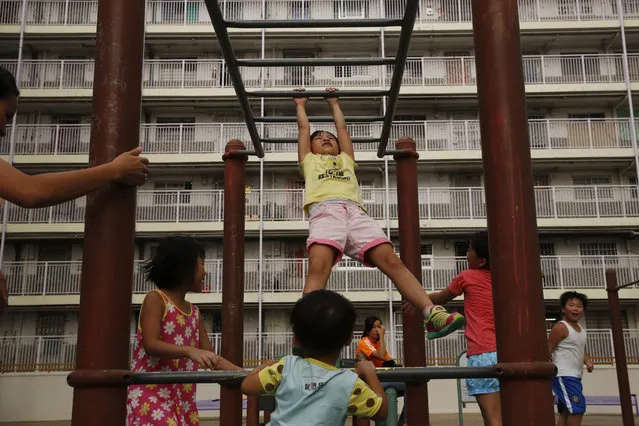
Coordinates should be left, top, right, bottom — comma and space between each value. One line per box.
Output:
71, 0, 145, 426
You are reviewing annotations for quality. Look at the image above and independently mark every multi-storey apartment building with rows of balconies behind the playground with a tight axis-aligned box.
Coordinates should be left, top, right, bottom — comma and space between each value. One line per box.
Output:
0, 0, 639, 420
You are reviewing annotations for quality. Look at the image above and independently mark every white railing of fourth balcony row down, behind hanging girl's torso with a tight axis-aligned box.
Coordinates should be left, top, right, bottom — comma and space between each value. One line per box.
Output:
0, 185, 639, 228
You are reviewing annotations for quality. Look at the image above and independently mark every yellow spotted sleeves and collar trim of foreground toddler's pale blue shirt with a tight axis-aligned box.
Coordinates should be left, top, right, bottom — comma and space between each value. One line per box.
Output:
258, 357, 383, 417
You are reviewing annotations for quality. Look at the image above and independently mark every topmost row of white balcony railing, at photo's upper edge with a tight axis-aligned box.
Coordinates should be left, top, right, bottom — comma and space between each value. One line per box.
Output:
0, 0, 639, 26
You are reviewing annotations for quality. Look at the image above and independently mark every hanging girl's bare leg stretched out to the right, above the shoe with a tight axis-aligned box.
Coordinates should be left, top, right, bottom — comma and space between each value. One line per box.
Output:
366, 244, 433, 311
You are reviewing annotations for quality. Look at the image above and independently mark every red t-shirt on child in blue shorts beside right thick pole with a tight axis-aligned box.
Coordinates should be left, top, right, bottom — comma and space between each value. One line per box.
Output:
448, 269, 497, 356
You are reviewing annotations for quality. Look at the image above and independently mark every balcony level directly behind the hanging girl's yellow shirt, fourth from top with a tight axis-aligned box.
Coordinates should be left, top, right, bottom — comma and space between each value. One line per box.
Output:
0, 185, 639, 235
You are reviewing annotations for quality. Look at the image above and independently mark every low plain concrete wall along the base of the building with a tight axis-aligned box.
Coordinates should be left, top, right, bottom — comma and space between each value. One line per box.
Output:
0, 366, 639, 422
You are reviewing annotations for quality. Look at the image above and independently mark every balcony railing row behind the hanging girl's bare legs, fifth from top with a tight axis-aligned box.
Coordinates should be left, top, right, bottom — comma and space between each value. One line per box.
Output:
2, 255, 639, 296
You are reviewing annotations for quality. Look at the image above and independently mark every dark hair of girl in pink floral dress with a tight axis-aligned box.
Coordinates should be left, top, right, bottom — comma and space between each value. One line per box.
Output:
144, 236, 205, 290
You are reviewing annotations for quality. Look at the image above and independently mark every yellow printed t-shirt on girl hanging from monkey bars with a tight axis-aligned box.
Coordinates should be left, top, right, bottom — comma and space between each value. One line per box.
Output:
300, 152, 366, 214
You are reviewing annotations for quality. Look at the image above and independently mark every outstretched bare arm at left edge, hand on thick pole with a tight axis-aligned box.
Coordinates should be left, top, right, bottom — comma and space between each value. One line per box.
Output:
0, 147, 149, 208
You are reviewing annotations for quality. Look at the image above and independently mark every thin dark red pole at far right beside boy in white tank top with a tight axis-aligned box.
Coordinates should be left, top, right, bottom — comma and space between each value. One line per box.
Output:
606, 269, 635, 426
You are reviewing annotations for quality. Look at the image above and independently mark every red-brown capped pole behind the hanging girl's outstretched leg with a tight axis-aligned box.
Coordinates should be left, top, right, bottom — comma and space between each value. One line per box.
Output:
394, 138, 430, 426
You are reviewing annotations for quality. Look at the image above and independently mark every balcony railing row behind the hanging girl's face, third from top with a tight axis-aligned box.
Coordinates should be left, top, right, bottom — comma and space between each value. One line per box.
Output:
0, 118, 632, 155
